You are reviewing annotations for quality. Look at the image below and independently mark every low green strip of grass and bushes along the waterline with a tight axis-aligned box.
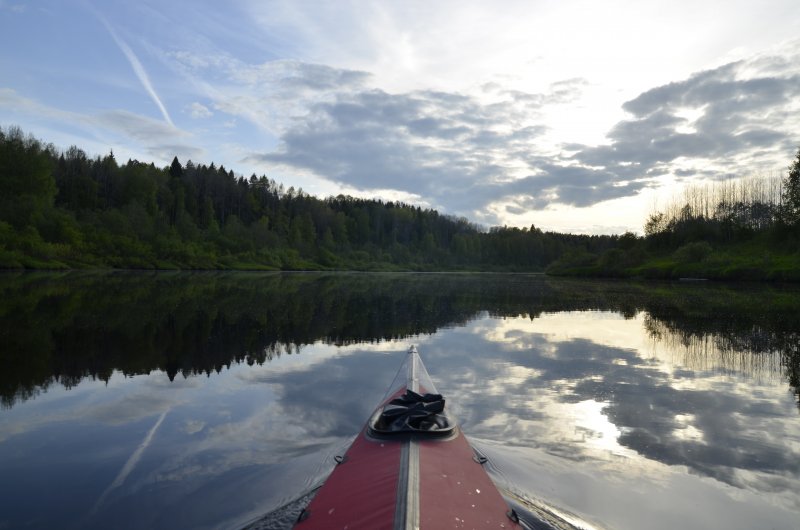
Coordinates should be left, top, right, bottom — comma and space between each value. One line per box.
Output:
6, 242, 800, 282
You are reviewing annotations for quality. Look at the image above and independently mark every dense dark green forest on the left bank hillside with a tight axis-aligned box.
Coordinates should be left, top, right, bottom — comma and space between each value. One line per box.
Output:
0, 128, 619, 271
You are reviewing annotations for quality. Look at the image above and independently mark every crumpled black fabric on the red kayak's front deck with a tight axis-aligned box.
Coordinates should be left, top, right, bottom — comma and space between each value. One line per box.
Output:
373, 390, 451, 433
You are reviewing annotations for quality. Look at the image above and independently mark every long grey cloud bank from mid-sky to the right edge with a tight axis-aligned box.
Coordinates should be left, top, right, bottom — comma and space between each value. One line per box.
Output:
223, 43, 800, 221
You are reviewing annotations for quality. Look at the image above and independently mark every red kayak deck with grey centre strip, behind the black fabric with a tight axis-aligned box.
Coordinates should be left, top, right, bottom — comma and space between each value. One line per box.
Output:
295, 350, 519, 530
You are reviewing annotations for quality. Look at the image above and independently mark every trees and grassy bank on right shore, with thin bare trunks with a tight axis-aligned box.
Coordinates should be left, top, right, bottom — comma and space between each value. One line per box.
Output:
549, 146, 800, 281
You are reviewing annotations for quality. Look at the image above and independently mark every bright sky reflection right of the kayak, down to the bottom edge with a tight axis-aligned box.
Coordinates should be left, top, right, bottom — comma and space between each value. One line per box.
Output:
418, 312, 800, 528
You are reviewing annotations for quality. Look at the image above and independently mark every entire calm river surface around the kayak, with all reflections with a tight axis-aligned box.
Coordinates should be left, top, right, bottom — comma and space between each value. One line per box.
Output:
0, 273, 800, 529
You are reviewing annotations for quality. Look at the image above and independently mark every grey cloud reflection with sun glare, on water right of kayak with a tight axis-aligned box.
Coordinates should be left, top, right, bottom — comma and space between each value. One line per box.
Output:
416, 313, 800, 511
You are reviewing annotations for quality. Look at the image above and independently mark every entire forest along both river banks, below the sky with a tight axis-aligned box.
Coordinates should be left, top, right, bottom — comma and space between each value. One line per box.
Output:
0, 127, 800, 281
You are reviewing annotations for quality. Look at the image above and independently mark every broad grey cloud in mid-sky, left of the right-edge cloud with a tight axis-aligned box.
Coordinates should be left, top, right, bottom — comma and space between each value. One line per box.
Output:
251, 82, 560, 212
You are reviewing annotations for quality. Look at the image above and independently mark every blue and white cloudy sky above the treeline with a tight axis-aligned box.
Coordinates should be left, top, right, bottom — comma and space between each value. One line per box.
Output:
0, 0, 800, 233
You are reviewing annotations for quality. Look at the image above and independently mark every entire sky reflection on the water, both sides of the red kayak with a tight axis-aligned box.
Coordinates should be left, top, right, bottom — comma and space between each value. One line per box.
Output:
0, 274, 800, 529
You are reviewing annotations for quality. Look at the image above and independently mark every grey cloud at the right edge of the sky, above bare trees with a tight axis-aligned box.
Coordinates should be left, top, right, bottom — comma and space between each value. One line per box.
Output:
574, 51, 800, 174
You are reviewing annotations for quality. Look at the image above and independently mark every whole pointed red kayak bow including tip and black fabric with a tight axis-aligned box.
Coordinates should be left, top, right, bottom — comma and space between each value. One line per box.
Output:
295, 346, 520, 530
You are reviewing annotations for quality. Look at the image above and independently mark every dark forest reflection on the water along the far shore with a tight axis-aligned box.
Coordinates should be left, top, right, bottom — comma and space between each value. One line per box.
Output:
0, 272, 800, 407
